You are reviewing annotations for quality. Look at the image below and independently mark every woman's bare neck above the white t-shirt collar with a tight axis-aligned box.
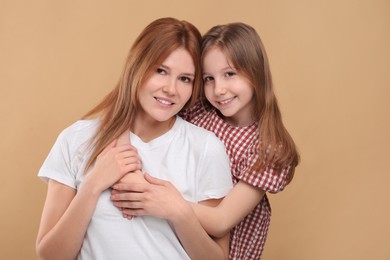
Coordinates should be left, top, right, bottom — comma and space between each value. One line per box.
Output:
131, 116, 176, 143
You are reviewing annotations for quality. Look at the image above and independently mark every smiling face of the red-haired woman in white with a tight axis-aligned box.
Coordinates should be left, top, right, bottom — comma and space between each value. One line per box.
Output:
136, 48, 195, 124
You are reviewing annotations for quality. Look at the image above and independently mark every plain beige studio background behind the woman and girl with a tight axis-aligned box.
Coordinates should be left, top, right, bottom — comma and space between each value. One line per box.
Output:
0, 0, 390, 260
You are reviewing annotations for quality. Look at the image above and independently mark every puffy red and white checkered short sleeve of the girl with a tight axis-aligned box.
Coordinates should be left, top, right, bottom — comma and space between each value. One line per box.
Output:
235, 140, 290, 193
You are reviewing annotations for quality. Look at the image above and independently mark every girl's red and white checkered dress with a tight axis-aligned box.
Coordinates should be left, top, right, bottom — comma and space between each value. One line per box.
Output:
181, 102, 289, 260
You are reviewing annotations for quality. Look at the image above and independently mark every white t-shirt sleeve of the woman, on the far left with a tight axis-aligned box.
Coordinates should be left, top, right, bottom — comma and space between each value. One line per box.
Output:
38, 123, 82, 189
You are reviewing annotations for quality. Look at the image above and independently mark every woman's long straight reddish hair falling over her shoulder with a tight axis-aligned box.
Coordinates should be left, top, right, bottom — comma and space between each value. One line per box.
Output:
83, 17, 201, 171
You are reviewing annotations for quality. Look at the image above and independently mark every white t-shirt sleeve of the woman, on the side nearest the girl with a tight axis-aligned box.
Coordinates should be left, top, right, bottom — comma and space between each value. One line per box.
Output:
197, 132, 233, 201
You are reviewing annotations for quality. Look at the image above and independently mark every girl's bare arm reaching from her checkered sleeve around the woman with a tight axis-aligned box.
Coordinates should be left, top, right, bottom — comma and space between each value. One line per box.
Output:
191, 181, 265, 237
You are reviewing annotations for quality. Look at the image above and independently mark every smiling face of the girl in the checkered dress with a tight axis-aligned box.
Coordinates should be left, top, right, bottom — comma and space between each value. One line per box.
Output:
203, 47, 254, 126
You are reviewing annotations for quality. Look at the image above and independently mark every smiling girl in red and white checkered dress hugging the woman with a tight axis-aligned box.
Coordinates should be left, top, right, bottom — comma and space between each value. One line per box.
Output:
113, 23, 299, 259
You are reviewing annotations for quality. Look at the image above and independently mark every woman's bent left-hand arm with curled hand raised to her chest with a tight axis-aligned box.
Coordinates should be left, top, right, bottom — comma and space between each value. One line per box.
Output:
36, 137, 139, 259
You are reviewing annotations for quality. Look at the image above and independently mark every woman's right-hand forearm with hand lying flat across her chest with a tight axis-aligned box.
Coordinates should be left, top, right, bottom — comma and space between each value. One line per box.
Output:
111, 173, 229, 259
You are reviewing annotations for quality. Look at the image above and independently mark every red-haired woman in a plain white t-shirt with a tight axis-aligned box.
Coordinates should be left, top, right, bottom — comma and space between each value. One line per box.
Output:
37, 18, 232, 260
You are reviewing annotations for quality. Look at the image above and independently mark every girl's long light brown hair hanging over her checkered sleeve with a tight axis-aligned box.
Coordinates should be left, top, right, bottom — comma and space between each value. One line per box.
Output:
201, 23, 299, 182
